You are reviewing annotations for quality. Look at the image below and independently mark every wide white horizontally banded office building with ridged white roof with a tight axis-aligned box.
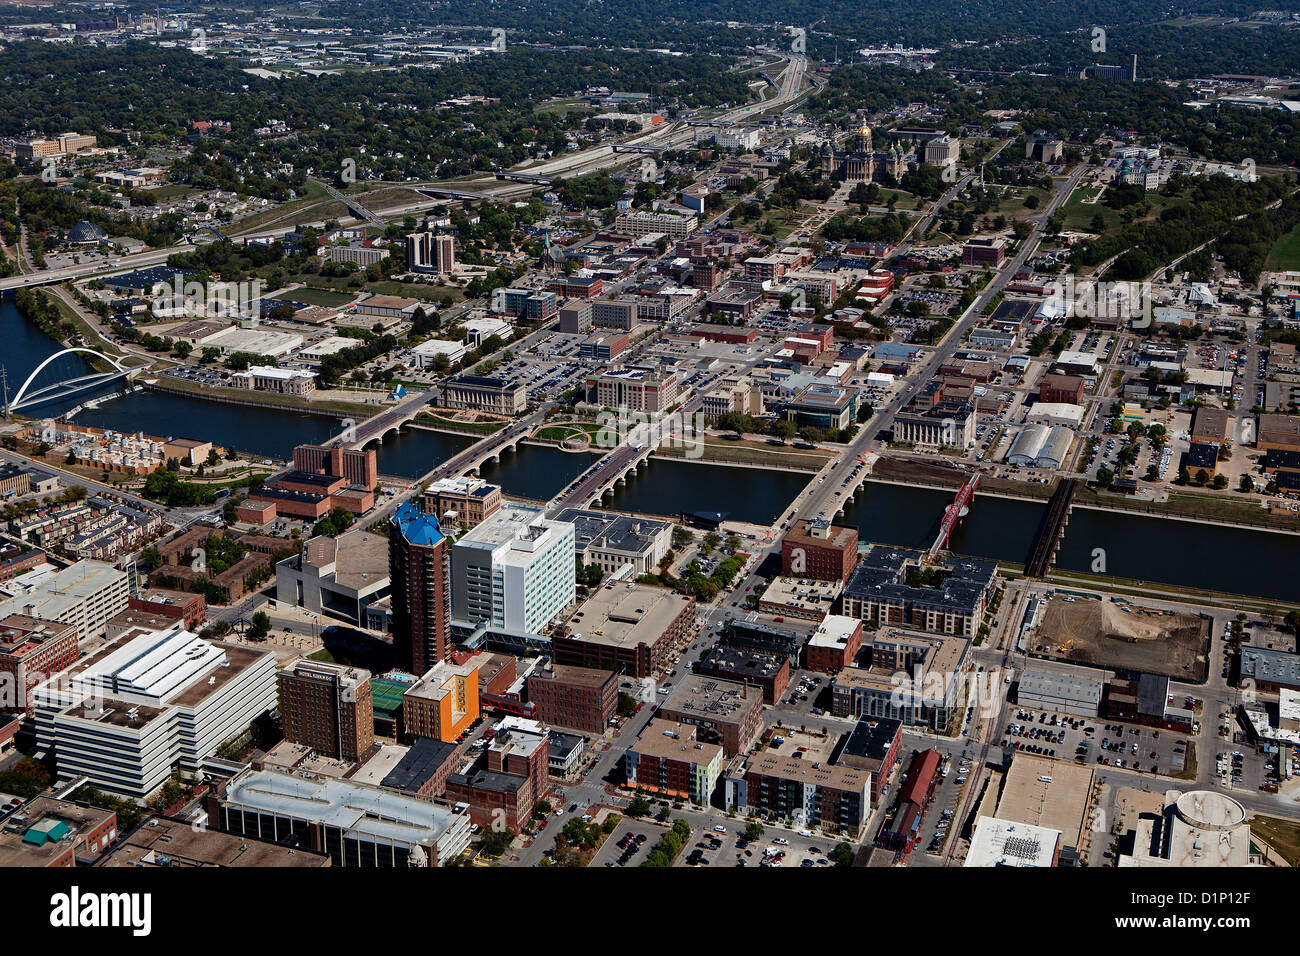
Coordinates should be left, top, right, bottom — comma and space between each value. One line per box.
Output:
33, 622, 276, 797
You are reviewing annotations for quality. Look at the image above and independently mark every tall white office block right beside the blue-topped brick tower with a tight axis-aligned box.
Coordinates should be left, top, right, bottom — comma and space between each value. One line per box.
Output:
451, 502, 577, 633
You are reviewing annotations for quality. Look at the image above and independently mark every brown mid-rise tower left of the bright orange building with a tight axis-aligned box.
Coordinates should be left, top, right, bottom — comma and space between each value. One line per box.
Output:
280, 661, 374, 761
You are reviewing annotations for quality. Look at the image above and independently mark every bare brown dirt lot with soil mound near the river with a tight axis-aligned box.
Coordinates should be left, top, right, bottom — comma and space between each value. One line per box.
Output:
1034, 594, 1208, 680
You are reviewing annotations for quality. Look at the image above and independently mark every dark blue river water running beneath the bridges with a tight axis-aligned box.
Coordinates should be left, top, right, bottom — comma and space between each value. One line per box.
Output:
0, 298, 1300, 600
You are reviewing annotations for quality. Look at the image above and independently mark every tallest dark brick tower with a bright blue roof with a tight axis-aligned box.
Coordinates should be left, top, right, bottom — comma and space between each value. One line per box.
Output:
389, 501, 451, 674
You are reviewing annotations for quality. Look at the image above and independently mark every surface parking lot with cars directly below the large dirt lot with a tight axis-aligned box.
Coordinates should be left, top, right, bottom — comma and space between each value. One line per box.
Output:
1002, 708, 1187, 777
